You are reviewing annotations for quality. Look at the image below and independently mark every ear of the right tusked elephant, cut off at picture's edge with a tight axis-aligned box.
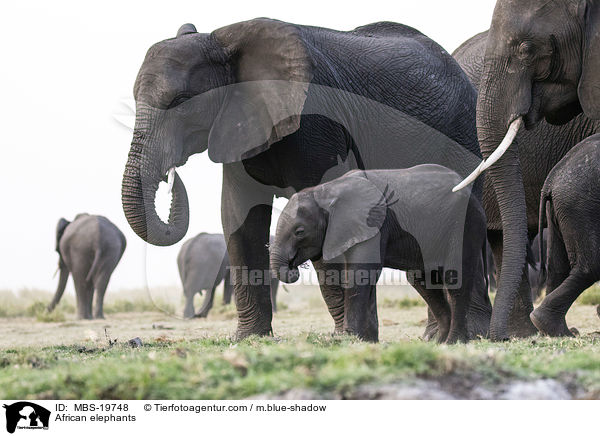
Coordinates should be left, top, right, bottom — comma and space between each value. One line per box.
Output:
577, 1, 600, 120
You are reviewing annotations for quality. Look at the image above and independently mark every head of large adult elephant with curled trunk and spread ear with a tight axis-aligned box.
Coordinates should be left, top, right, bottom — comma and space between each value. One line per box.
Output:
122, 19, 312, 245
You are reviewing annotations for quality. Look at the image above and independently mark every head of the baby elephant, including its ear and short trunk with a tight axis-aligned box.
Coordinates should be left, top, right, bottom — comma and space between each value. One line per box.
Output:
271, 171, 386, 283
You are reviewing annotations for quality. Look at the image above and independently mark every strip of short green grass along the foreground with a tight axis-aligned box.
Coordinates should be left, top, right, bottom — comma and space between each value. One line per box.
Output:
0, 334, 600, 399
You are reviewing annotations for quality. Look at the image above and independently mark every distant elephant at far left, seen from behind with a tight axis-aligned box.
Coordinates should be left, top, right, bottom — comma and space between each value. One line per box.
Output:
48, 213, 127, 319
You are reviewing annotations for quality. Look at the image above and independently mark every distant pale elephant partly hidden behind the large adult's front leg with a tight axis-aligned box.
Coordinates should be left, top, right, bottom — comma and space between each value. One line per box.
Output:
177, 233, 279, 318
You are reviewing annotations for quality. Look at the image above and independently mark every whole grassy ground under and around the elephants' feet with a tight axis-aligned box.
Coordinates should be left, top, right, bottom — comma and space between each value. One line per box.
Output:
0, 286, 600, 399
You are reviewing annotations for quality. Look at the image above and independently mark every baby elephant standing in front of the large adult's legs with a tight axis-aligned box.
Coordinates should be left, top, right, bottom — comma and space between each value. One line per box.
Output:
271, 165, 491, 343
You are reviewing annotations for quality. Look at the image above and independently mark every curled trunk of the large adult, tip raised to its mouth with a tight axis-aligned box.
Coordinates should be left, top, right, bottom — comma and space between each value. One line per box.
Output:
121, 129, 189, 246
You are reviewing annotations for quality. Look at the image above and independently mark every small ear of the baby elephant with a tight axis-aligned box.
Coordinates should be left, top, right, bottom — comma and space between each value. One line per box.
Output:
314, 171, 387, 261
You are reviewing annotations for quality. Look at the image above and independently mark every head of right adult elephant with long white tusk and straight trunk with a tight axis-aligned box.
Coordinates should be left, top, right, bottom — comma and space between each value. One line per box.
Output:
457, 0, 600, 339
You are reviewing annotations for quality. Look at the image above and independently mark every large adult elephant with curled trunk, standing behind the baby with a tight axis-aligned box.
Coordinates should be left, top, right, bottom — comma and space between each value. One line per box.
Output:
122, 18, 483, 338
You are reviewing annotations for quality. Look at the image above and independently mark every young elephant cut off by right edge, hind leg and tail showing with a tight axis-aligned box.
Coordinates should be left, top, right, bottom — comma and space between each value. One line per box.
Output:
530, 134, 600, 336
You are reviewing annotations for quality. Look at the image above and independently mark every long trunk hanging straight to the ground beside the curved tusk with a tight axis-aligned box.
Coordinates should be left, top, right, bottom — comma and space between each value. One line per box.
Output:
477, 61, 531, 341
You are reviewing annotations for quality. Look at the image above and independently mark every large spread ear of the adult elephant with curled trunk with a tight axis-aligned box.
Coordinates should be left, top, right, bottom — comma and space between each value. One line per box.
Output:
208, 18, 313, 163
